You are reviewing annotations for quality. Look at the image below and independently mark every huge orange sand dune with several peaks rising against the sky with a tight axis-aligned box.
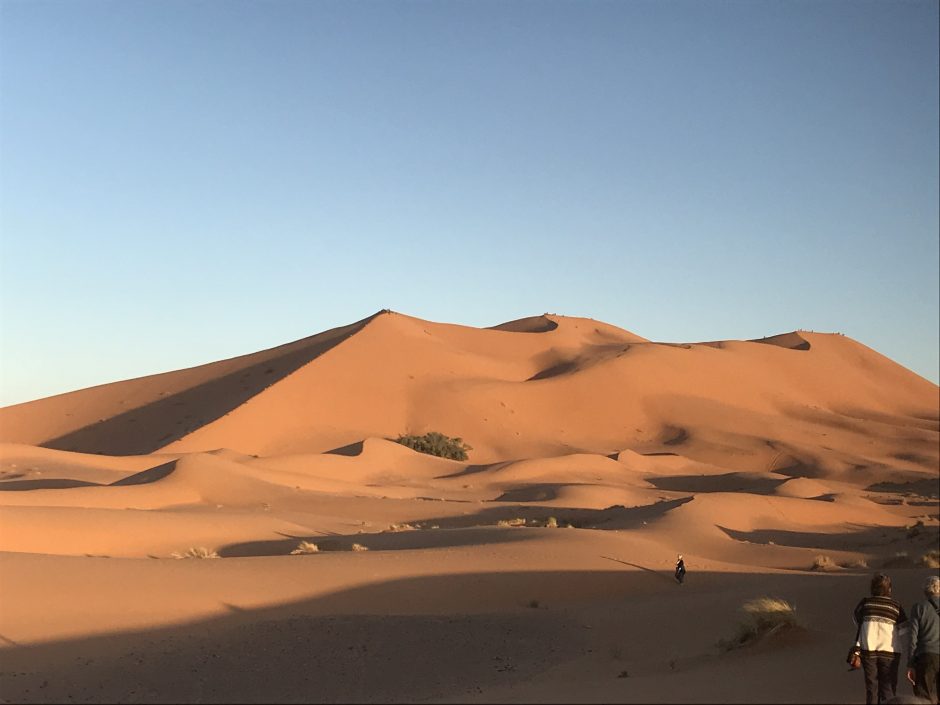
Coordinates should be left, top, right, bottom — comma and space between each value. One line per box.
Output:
0, 311, 938, 468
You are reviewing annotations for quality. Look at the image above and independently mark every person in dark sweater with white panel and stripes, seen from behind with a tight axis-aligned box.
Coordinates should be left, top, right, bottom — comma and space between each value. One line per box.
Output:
854, 573, 907, 705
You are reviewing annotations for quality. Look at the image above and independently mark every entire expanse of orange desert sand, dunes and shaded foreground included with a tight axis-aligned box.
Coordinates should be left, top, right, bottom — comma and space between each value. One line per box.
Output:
0, 311, 940, 703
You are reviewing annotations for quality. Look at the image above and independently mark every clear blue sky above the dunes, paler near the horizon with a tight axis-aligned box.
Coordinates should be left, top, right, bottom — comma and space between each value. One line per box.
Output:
0, 0, 940, 404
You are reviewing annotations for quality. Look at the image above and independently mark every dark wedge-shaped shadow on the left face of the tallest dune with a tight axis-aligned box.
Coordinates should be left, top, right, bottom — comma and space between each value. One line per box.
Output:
40, 314, 379, 455
